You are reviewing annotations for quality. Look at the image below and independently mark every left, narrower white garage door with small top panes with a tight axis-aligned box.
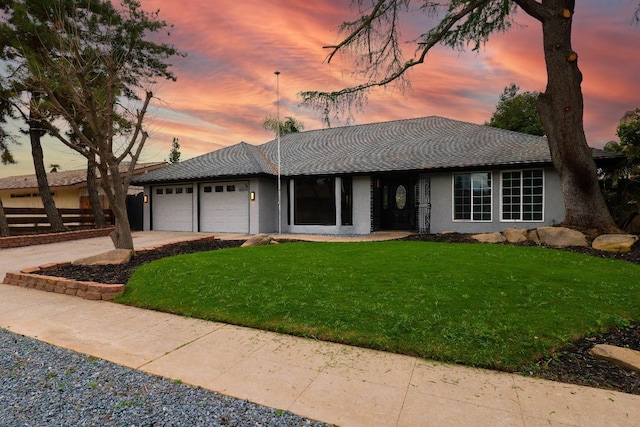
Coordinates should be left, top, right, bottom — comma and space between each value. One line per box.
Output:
151, 185, 193, 231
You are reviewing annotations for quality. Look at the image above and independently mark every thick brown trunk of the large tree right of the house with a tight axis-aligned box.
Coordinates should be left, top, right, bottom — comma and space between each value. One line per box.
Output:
538, 0, 620, 232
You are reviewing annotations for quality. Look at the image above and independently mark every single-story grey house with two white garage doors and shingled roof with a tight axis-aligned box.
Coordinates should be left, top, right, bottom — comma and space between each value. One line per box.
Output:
134, 116, 619, 235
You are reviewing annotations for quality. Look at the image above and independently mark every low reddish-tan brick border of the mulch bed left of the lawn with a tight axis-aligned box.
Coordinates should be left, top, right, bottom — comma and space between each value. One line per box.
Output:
2, 235, 215, 301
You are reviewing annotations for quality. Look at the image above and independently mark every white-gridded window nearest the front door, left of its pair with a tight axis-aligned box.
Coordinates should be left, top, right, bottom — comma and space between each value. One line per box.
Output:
453, 172, 491, 221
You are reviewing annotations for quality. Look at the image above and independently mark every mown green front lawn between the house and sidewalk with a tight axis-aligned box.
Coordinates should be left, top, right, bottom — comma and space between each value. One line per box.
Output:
118, 241, 640, 370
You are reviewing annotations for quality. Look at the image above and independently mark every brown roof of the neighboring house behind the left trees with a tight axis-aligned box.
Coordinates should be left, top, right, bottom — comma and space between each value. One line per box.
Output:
0, 162, 166, 191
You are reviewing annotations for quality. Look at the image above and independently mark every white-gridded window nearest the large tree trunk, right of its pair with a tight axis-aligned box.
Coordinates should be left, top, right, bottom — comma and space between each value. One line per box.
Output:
502, 169, 544, 221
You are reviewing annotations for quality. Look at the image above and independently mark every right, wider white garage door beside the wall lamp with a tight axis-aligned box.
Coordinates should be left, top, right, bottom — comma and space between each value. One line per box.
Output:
200, 181, 249, 233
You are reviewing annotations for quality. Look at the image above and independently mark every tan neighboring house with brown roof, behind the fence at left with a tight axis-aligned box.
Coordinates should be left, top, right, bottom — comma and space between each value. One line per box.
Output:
0, 162, 167, 209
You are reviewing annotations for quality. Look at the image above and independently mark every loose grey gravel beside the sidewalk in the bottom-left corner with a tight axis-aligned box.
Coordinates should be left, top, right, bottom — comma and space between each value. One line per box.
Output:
0, 329, 325, 426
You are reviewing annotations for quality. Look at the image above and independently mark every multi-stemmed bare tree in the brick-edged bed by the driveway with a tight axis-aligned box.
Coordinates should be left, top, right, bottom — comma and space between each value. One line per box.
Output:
7, 0, 180, 249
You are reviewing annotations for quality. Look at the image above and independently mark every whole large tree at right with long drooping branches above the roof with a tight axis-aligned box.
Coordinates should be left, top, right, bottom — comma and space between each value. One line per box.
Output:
301, 0, 640, 232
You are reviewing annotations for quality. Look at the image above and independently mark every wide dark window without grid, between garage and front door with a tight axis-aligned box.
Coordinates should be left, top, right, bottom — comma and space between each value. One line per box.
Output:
293, 177, 336, 225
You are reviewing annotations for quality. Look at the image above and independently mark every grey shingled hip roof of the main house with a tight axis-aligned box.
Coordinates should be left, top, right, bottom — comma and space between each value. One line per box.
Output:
135, 116, 618, 183
